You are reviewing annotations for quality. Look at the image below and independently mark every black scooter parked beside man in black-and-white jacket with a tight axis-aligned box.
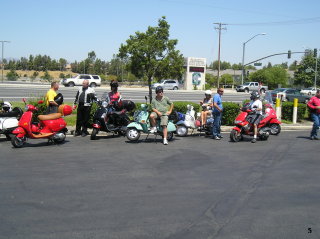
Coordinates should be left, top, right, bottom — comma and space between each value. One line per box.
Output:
90, 100, 135, 140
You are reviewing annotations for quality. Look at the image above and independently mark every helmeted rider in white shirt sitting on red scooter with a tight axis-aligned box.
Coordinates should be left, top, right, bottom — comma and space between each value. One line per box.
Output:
249, 91, 262, 143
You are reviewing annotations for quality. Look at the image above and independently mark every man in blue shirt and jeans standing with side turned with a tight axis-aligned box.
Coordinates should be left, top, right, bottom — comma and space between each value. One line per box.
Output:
212, 88, 223, 140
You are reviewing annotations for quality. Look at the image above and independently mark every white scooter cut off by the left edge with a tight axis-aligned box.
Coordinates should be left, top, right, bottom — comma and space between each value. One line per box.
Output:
0, 101, 23, 140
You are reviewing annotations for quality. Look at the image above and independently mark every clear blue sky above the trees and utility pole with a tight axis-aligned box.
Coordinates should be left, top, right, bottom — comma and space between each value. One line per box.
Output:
0, 0, 320, 67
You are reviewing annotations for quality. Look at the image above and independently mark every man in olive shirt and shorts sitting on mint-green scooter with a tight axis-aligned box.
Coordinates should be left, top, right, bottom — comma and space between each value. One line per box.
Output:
150, 86, 174, 145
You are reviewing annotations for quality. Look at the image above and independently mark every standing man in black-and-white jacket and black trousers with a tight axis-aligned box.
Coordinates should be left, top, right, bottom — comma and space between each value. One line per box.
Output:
73, 80, 97, 137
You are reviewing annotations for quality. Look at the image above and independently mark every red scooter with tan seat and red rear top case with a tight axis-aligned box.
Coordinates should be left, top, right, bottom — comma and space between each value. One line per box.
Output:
11, 100, 72, 148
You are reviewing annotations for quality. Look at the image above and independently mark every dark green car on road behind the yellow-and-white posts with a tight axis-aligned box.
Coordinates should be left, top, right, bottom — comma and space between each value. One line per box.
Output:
271, 88, 311, 103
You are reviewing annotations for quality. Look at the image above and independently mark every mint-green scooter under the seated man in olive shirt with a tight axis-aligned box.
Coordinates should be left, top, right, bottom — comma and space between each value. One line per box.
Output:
126, 97, 176, 141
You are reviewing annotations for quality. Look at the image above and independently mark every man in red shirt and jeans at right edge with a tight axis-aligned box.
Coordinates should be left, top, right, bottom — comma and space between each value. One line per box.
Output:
308, 90, 320, 140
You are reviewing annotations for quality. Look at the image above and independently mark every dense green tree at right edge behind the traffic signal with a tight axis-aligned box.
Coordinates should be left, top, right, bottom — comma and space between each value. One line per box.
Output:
294, 54, 319, 87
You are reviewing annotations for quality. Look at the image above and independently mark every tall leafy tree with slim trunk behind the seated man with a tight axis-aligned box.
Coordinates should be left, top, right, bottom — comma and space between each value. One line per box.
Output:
118, 17, 184, 101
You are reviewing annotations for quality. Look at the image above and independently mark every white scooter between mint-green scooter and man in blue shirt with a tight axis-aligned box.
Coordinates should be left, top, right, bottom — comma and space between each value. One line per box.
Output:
176, 105, 213, 137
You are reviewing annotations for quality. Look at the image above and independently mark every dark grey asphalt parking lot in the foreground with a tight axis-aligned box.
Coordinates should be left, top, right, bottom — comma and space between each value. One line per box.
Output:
0, 131, 320, 239
